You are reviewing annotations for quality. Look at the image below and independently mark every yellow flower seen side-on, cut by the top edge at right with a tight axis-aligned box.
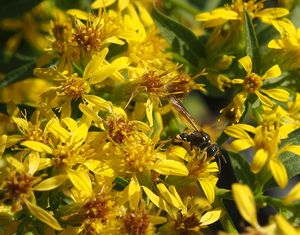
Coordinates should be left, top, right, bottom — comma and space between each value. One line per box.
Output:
196, 0, 289, 28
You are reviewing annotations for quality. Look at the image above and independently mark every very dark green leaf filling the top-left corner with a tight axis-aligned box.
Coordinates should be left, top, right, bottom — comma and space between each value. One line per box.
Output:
0, 0, 41, 19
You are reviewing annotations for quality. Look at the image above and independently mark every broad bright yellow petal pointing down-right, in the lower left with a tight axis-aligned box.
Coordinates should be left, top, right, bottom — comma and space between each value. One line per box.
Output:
67, 169, 93, 195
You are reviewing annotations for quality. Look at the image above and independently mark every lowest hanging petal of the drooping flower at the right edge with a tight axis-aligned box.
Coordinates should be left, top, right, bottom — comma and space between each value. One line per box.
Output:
270, 159, 288, 188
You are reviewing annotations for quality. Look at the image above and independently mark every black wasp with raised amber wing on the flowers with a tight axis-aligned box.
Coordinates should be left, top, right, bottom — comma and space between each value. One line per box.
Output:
170, 96, 221, 158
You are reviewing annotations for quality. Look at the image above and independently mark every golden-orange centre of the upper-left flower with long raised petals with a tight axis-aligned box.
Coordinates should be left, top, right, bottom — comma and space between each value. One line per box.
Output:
62, 74, 88, 99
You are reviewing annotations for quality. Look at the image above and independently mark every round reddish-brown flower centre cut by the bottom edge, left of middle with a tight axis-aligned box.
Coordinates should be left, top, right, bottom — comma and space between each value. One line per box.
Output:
123, 210, 150, 235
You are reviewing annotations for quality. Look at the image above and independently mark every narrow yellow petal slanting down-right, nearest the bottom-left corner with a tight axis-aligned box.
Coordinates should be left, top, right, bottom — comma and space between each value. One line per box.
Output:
24, 199, 63, 230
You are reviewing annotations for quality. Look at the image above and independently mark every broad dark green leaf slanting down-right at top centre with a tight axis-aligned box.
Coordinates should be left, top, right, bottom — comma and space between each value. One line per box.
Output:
152, 7, 200, 64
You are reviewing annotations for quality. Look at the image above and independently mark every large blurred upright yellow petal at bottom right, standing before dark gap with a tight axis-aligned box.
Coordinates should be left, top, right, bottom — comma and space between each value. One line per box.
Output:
232, 183, 258, 227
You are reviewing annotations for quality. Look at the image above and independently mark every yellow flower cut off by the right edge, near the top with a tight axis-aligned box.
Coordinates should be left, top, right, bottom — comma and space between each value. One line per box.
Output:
268, 19, 300, 70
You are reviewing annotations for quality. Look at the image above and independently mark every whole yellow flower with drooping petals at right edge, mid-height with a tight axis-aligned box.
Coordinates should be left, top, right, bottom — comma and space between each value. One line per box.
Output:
225, 108, 300, 188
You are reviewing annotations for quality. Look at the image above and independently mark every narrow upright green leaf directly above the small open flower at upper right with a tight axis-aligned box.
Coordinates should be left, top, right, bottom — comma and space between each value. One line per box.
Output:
244, 10, 261, 74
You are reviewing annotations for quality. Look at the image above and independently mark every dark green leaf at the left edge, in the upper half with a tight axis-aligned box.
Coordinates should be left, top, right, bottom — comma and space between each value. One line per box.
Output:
0, 61, 35, 89
